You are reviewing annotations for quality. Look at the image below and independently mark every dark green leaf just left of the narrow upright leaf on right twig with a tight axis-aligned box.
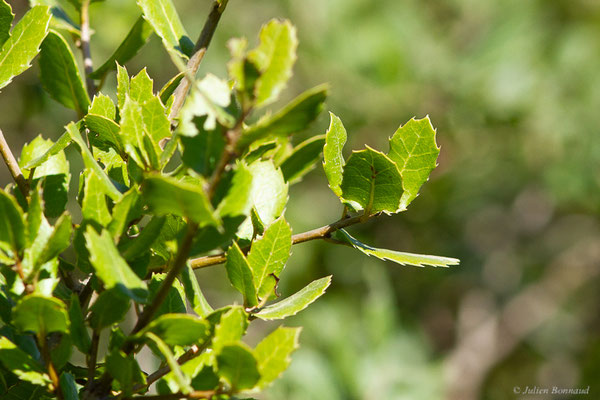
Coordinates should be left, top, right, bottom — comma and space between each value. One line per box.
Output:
281, 135, 325, 183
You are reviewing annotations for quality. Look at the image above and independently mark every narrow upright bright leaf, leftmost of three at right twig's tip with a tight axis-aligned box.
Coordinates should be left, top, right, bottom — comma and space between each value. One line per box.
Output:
323, 112, 348, 197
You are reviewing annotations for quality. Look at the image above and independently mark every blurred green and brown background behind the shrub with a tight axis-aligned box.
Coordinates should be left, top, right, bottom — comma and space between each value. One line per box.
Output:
0, 0, 600, 400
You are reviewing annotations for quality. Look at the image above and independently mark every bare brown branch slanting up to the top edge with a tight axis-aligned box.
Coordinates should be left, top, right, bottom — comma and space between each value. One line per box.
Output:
169, 0, 228, 121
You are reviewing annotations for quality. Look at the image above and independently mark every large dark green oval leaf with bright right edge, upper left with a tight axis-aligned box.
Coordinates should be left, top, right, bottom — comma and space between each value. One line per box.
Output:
40, 31, 90, 116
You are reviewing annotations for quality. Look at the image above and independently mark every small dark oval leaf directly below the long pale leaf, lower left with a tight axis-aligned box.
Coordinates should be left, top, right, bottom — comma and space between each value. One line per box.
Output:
89, 288, 130, 331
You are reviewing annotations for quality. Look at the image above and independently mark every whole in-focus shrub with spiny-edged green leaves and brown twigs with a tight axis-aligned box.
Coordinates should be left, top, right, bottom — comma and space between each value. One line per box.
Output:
0, 0, 457, 399
